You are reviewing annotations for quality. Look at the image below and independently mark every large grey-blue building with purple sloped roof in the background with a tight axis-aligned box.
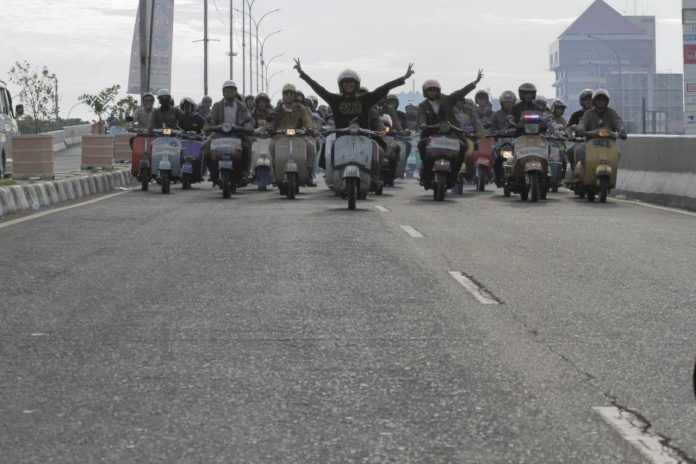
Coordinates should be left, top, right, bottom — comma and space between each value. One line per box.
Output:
549, 0, 684, 133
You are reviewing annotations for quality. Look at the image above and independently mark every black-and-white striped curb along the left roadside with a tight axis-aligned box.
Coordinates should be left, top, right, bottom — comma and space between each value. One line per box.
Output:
0, 171, 133, 217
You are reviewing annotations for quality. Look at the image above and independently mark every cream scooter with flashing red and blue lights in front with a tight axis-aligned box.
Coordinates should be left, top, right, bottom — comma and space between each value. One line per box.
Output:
503, 111, 549, 202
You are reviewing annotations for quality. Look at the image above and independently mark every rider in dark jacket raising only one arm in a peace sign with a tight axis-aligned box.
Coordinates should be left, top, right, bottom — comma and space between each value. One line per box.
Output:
418, 69, 483, 186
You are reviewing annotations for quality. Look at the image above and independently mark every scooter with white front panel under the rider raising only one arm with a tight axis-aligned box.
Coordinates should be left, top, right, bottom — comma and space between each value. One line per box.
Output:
421, 121, 466, 201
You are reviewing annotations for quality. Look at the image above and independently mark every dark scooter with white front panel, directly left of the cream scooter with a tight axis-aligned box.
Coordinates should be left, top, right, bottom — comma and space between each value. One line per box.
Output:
208, 122, 253, 198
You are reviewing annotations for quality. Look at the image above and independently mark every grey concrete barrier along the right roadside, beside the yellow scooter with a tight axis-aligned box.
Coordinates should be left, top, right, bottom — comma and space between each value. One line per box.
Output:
612, 135, 696, 210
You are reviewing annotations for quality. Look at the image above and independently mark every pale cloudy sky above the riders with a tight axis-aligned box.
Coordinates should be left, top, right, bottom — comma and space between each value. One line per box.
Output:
0, 0, 683, 119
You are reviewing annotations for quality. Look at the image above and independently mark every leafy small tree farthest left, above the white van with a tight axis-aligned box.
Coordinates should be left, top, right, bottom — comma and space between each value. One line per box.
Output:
8, 60, 58, 134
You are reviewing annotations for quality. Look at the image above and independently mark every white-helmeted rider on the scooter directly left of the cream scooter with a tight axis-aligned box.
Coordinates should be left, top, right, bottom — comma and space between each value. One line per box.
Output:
201, 80, 253, 184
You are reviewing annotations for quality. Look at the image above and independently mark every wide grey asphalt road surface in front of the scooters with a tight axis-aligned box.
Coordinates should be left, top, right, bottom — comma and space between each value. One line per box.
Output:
0, 181, 696, 463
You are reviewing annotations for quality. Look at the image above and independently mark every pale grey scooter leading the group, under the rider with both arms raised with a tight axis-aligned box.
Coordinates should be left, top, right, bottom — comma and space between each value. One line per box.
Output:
325, 122, 381, 210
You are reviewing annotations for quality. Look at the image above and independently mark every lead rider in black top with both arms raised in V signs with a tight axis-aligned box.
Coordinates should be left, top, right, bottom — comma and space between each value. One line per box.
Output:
295, 59, 413, 129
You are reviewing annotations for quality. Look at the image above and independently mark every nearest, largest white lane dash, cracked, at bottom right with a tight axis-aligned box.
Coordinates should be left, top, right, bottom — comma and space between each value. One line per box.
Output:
592, 406, 682, 464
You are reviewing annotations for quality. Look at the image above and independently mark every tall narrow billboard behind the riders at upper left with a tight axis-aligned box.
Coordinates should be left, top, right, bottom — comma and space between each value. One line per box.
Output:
128, 0, 174, 94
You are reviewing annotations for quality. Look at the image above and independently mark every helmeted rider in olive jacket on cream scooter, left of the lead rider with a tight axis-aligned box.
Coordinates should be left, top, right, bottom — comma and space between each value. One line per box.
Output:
267, 84, 317, 187
